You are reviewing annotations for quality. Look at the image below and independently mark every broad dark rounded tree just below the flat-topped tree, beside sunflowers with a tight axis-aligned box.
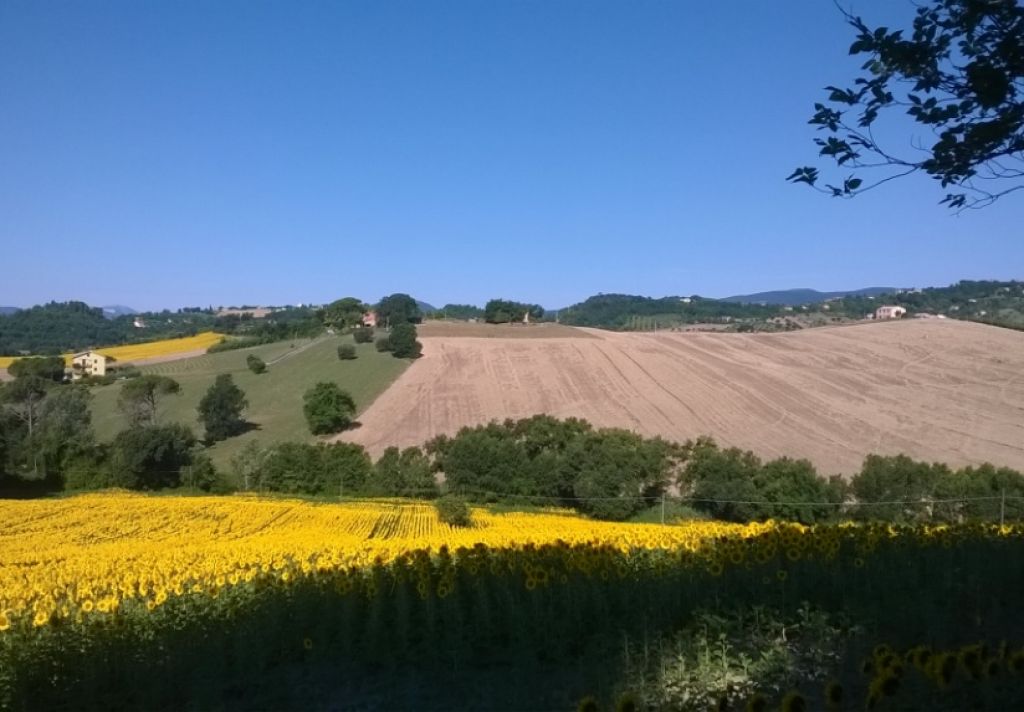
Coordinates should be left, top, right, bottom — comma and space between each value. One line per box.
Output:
110, 423, 196, 490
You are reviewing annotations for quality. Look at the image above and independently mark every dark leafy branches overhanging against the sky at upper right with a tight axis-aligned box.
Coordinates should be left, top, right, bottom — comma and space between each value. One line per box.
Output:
788, 0, 1024, 210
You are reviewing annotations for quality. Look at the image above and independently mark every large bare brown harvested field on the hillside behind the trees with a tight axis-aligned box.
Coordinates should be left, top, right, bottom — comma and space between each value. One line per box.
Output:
345, 320, 1024, 474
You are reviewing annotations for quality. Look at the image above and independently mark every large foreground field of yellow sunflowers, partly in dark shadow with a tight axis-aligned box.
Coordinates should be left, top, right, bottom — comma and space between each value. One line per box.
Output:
0, 492, 1024, 709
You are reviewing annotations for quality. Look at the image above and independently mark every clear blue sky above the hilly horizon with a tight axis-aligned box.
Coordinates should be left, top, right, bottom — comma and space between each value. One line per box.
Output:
0, 0, 1024, 308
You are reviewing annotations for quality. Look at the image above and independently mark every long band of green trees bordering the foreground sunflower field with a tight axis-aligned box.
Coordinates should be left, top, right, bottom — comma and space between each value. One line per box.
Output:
0, 387, 1024, 523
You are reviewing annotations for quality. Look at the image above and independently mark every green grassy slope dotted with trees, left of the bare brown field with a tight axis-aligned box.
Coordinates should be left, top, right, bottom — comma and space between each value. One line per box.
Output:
92, 336, 409, 467
